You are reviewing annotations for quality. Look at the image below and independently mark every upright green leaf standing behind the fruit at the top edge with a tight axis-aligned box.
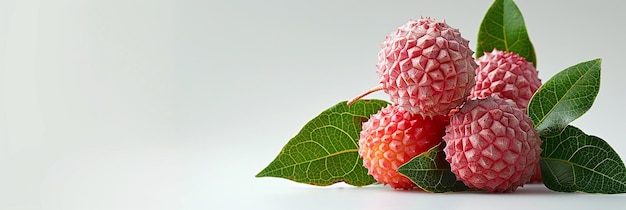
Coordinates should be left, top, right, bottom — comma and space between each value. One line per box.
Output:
476, 0, 537, 67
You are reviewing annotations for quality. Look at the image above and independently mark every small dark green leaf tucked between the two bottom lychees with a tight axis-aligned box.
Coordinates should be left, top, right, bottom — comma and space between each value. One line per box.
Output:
398, 143, 468, 193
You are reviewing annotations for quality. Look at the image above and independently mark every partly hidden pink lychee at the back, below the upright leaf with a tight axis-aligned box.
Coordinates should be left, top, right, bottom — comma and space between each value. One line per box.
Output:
469, 49, 541, 109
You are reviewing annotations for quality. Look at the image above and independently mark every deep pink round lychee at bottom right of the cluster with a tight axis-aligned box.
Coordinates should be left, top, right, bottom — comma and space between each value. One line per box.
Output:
443, 97, 541, 192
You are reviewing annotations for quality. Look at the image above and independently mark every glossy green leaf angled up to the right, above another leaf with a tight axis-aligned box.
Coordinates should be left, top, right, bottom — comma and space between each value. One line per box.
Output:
528, 59, 602, 135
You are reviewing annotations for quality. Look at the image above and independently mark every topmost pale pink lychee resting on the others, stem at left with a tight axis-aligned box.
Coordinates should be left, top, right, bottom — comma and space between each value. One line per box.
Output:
376, 18, 477, 117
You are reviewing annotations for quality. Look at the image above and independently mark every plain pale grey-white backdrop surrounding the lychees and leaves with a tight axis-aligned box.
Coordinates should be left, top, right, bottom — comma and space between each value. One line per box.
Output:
0, 0, 626, 209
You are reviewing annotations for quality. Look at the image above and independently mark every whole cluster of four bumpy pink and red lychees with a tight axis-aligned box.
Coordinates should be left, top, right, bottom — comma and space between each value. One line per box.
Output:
349, 17, 541, 192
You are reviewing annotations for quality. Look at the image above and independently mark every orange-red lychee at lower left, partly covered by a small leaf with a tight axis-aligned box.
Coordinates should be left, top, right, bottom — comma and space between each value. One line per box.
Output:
359, 105, 448, 189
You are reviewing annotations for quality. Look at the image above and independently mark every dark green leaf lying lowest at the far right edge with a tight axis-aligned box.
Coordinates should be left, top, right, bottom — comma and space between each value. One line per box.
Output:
541, 126, 626, 193
